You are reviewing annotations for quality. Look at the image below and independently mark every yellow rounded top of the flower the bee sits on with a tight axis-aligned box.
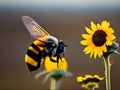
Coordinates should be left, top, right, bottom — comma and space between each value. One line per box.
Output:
44, 57, 68, 72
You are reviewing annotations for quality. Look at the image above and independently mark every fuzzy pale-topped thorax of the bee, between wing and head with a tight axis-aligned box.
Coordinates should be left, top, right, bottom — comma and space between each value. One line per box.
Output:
44, 36, 58, 55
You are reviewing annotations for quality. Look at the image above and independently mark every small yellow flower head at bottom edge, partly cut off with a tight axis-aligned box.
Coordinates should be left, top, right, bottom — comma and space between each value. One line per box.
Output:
77, 75, 104, 89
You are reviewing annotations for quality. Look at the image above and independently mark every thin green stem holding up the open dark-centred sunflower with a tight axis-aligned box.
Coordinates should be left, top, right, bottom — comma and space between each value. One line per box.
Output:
104, 56, 111, 90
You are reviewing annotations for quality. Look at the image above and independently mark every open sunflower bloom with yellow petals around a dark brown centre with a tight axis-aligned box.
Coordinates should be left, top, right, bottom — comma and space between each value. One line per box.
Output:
80, 21, 116, 58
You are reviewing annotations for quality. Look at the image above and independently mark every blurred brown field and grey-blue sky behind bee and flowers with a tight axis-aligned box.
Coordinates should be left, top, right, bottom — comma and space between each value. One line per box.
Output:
0, 0, 120, 90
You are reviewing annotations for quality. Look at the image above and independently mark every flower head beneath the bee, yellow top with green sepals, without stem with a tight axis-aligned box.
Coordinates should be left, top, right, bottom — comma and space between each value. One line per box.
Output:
35, 56, 72, 82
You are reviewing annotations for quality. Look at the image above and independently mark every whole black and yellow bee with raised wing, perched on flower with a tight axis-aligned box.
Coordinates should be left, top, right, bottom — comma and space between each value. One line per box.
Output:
22, 16, 67, 72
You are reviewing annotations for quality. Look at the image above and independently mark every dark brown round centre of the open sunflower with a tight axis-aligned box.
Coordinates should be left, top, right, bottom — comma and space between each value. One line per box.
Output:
92, 30, 107, 46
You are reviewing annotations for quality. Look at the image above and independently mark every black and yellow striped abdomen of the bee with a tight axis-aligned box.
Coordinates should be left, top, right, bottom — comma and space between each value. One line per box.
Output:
25, 40, 45, 71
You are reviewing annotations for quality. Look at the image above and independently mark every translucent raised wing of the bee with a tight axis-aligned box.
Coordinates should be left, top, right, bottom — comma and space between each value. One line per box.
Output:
22, 16, 50, 39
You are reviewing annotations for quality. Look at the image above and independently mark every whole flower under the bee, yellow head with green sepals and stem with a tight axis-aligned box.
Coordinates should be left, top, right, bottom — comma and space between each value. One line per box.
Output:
35, 56, 72, 90
